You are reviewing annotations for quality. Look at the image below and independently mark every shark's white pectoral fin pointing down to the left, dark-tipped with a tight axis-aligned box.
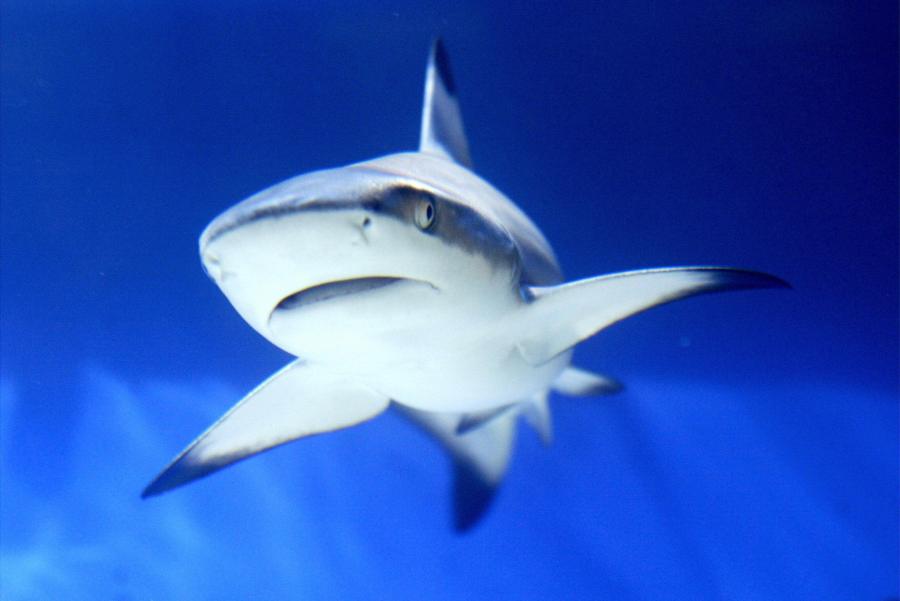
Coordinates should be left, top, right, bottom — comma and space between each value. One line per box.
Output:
141, 360, 390, 498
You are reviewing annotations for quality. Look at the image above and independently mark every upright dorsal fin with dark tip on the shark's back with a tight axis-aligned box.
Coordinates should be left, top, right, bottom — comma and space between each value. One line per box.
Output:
419, 38, 472, 167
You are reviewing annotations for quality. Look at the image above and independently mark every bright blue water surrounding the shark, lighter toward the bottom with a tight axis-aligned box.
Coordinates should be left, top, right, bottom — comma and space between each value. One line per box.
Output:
0, 0, 900, 601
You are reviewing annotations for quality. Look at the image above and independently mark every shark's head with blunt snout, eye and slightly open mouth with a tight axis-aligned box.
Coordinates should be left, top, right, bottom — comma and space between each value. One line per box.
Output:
200, 153, 521, 356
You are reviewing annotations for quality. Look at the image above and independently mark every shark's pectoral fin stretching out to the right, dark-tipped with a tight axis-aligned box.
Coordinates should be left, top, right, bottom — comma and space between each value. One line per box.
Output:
518, 267, 789, 365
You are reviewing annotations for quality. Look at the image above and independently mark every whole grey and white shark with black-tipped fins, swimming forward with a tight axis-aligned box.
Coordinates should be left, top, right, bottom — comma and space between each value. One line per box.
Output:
142, 39, 788, 531
